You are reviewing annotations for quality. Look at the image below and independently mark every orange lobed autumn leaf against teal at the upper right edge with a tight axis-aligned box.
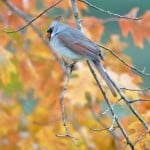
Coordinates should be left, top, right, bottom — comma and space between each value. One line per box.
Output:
119, 8, 150, 48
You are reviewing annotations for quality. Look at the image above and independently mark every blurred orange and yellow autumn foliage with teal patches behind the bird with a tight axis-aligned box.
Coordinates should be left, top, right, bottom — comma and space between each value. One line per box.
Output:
0, 0, 150, 150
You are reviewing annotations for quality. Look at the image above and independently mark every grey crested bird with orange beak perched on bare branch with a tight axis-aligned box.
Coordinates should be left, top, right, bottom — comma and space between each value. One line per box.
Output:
46, 18, 117, 97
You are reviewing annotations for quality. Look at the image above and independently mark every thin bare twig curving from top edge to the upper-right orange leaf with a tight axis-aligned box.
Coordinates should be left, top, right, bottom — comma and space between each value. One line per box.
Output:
78, 0, 142, 20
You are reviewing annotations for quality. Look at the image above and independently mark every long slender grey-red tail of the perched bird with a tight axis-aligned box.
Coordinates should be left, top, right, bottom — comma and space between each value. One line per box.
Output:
93, 61, 117, 97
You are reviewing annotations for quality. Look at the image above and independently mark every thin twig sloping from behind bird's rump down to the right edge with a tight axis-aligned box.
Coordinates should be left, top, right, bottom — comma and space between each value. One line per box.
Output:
97, 44, 150, 76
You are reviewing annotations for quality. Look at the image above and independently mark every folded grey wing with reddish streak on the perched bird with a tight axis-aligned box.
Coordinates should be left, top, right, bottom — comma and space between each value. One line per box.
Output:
58, 27, 102, 60
